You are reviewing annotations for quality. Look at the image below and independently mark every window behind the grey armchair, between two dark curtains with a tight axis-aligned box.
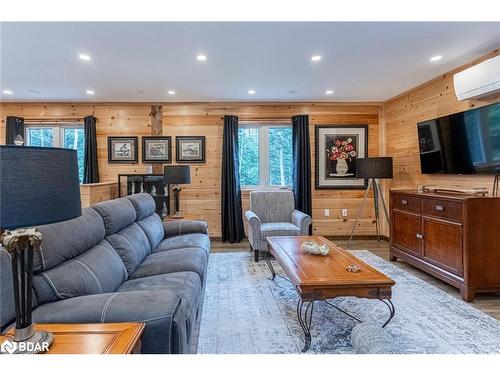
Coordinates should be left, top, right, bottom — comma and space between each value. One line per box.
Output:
238, 124, 292, 188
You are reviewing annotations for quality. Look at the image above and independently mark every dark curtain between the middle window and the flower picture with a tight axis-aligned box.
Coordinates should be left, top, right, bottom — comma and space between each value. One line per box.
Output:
292, 115, 312, 234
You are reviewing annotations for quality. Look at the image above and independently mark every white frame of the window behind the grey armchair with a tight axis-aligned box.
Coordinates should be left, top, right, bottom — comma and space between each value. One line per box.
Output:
238, 122, 292, 191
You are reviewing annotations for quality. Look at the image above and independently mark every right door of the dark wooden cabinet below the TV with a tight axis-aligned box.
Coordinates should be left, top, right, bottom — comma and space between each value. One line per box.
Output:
422, 216, 463, 276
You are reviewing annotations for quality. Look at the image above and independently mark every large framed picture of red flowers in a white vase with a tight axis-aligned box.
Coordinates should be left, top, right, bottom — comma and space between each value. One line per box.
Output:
314, 125, 368, 189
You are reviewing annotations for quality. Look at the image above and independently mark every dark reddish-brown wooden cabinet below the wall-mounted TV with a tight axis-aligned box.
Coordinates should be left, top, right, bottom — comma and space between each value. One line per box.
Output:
390, 190, 500, 301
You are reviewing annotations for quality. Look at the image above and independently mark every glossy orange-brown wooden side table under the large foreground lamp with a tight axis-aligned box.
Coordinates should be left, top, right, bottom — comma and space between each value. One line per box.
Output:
0, 323, 144, 354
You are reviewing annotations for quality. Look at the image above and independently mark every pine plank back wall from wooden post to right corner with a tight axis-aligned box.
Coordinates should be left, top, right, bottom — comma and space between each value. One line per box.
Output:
163, 103, 380, 236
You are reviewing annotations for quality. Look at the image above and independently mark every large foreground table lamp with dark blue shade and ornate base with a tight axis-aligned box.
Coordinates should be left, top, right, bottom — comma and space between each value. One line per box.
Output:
0, 146, 82, 353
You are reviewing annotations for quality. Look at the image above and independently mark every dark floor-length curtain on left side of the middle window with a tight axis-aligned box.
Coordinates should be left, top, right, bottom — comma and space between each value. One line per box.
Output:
221, 116, 245, 243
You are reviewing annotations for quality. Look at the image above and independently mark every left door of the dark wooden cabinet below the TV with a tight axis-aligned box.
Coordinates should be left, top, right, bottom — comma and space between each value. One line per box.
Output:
392, 210, 422, 258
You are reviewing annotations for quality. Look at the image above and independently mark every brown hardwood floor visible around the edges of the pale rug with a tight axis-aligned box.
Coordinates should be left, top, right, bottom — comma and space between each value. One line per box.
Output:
212, 238, 500, 320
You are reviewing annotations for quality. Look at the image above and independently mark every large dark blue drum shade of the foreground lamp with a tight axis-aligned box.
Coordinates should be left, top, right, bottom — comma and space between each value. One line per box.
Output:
0, 146, 82, 229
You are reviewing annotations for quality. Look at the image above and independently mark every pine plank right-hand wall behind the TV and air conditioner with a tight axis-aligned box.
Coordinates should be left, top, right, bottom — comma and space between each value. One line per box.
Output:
382, 50, 500, 197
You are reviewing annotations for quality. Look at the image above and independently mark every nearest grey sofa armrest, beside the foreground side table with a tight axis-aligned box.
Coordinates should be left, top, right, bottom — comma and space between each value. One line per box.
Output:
33, 289, 186, 353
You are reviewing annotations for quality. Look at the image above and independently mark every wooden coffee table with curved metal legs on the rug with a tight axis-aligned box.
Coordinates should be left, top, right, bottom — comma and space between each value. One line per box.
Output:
266, 236, 395, 352
